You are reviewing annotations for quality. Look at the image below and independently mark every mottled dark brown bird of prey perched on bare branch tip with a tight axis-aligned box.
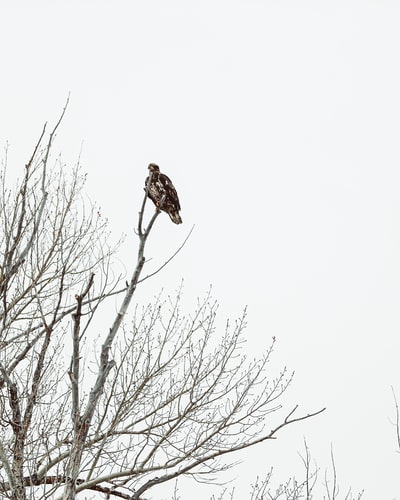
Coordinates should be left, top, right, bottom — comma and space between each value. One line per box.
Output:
145, 163, 182, 224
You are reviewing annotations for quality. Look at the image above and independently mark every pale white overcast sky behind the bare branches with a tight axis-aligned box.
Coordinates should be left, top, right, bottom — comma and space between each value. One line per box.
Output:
0, 0, 400, 500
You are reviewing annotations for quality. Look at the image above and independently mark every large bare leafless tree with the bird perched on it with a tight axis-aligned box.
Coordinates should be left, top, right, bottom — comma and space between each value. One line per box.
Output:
0, 109, 323, 500
